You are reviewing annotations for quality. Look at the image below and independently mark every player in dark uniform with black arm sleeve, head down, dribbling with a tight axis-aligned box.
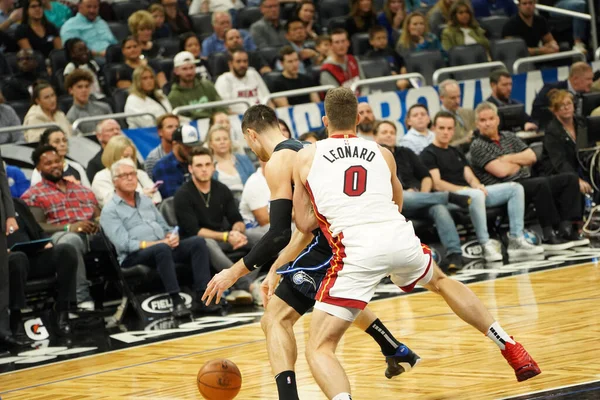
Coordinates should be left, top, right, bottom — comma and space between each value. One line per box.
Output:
202, 105, 420, 400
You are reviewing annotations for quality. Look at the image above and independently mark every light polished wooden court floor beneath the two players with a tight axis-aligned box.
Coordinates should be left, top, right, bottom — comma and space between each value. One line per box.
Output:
0, 264, 600, 400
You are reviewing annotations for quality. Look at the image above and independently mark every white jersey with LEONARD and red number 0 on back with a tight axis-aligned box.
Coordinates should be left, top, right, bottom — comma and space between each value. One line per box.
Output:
307, 136, 405, 237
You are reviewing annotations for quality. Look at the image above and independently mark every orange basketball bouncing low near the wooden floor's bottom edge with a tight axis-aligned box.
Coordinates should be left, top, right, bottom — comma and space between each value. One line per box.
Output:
197, 359, 242, 400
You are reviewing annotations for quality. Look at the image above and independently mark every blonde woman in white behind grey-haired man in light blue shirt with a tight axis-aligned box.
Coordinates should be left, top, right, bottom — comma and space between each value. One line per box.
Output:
92, 135, 162, 207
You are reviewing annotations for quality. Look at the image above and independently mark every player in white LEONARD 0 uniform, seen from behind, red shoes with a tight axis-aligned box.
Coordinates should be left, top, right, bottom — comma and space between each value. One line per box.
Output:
294, 87, 541, 400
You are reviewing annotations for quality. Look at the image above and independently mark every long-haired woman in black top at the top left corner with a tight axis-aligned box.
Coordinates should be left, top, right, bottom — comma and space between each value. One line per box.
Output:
15, 0, 62, 58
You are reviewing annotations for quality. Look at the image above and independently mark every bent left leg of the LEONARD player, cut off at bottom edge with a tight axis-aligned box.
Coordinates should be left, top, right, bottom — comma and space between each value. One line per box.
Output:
306, 302, 359, 400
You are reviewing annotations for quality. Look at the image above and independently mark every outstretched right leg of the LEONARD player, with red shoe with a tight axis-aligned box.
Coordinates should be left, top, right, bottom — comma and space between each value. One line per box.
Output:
424, 261, 541, 382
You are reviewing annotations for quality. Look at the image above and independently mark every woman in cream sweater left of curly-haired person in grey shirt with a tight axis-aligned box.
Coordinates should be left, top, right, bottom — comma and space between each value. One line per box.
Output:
23, 81, 72, 143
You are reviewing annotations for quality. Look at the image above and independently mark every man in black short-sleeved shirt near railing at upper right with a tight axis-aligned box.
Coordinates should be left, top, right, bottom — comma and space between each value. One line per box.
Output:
502, 0, 559, 56
